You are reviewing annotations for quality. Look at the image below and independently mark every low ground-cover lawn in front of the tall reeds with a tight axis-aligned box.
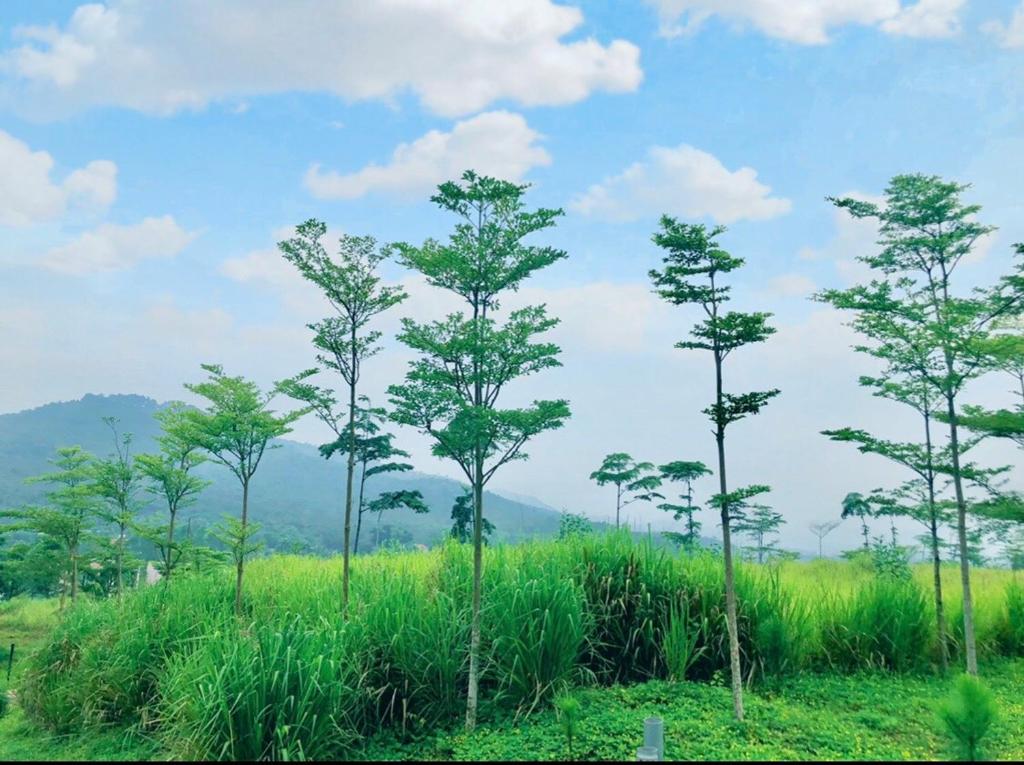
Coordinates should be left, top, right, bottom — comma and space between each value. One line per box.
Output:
365, 661, 1024, 761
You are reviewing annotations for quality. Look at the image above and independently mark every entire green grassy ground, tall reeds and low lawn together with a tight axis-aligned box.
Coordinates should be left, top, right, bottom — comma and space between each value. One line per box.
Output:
0, 535, 1024, 760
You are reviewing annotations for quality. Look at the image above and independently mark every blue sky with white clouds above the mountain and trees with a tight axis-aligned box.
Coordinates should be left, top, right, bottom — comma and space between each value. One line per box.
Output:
0, 0, 1024, 544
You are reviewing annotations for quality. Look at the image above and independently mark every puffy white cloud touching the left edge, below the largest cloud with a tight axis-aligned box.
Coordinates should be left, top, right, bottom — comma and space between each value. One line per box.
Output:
0, 130, 118, 226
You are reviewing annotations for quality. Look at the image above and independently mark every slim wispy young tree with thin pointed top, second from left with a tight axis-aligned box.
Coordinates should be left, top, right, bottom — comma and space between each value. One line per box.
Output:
93, 417, 141, 598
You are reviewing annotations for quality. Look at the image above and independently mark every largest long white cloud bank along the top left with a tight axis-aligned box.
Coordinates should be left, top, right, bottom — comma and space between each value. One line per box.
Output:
6, 0, 643, 117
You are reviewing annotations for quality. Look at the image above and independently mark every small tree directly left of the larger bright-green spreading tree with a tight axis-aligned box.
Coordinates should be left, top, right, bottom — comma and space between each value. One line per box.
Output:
135, 401, 210, 586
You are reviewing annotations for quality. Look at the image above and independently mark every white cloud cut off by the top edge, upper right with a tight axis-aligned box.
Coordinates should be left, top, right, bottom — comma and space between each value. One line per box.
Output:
646, 0, 967, 45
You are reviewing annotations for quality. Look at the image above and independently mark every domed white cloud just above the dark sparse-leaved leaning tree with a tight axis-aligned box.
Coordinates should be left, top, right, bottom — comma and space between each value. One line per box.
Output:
569, 143, 792, 223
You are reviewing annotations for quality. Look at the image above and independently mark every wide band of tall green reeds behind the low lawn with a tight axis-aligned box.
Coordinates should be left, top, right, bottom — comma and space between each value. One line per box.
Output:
9, 534, 1024, 759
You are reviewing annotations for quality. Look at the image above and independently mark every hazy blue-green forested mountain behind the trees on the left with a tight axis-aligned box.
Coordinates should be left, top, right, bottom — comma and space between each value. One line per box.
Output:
0, 394, 559, 551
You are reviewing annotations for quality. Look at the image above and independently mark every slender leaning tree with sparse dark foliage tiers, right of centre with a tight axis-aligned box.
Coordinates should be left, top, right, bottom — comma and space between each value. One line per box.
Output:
650, 216, 779, 720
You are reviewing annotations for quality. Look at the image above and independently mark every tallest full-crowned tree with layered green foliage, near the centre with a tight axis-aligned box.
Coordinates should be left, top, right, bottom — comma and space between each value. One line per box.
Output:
389, 171, 569, 730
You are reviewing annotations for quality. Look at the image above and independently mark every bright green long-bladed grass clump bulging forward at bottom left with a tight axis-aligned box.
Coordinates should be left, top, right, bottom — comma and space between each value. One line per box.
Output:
162, 617, 371, 761
